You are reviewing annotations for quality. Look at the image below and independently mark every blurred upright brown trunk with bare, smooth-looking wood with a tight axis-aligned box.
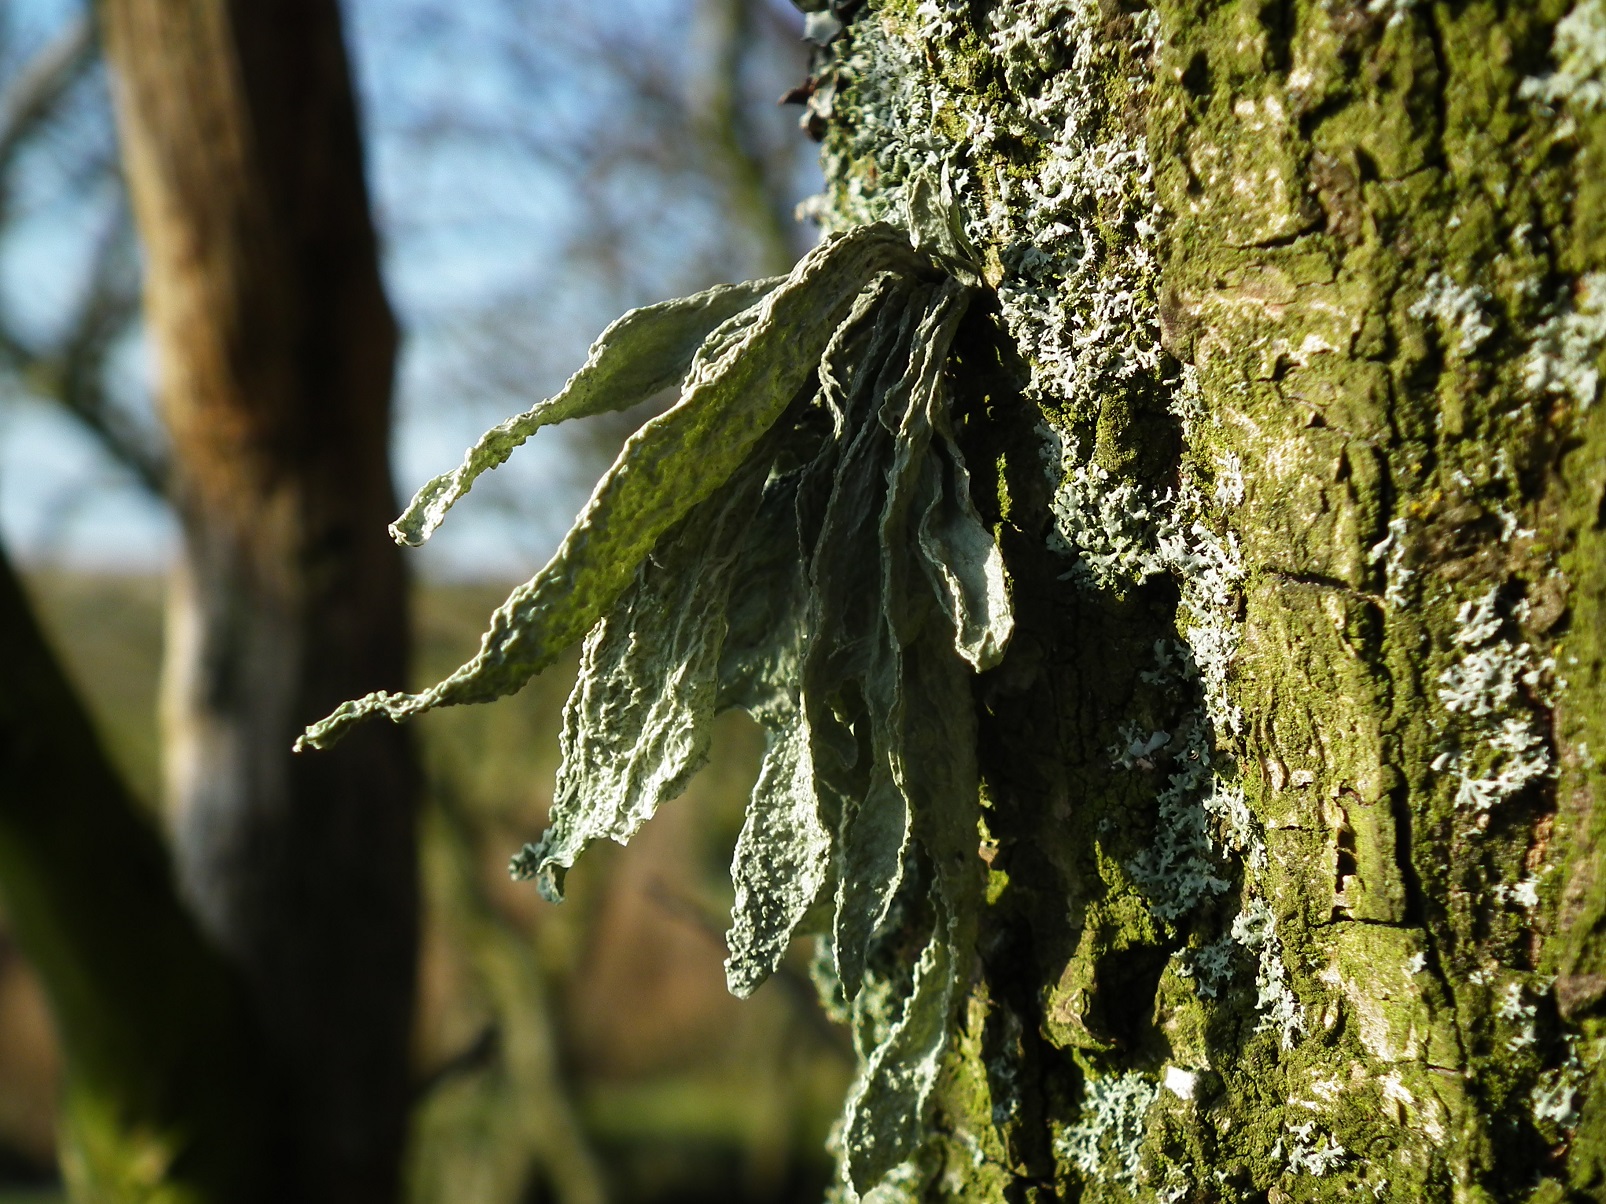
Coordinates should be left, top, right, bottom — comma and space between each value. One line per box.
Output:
101, 0, 418, 1202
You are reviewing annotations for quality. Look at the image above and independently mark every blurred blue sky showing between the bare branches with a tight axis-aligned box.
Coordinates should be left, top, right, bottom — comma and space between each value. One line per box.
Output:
0, 0, 811, 580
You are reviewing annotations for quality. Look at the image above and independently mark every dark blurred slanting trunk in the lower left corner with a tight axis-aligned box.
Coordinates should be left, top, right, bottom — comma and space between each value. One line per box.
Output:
0, 555, 273, 1204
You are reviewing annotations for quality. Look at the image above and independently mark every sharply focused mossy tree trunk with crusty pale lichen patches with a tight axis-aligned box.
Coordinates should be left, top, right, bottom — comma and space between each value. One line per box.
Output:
811, 0, 1606, 1201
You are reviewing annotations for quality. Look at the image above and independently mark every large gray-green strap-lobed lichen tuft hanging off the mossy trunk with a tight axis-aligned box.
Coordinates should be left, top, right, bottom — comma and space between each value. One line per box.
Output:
304, 211, 1013, 1193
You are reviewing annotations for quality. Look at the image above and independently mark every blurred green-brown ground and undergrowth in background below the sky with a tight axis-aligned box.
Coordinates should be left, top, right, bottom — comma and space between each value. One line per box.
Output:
0, 570, 851, 1204
